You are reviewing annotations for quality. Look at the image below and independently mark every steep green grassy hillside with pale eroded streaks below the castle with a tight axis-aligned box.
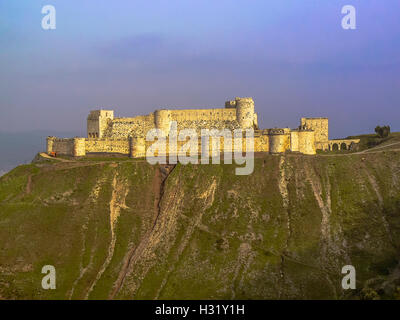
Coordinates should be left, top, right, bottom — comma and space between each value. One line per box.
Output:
0, 149, 400, 299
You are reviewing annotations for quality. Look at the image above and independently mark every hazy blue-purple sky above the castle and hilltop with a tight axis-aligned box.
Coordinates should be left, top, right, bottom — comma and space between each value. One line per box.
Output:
0, 0, 400, 138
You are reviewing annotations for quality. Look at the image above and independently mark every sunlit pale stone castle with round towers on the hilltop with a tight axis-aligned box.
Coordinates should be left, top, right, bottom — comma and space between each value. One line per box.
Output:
47, 98, 359, 158
